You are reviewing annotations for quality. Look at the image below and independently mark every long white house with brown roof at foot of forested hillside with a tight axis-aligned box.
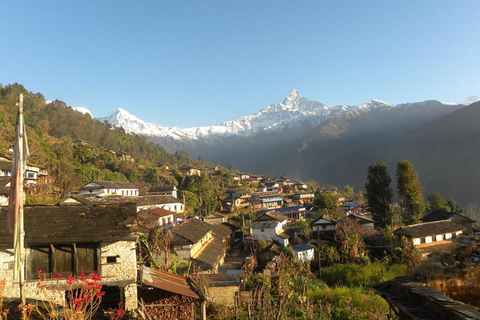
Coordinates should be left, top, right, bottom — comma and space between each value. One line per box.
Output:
78, 181, 139, 197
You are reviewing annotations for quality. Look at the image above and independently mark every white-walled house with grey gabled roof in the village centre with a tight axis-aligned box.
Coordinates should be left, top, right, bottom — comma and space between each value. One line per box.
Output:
250, 212, 289, 247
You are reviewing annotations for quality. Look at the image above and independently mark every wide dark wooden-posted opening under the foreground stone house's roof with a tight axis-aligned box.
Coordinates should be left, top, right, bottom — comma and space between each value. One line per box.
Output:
27, 243, 98, 280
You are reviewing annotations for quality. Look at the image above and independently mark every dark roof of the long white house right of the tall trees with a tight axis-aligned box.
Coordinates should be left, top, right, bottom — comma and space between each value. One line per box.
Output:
394, 220, 463, 238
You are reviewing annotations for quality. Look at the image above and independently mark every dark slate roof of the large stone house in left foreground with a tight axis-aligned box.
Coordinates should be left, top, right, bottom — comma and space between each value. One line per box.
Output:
0, 204, 137, 246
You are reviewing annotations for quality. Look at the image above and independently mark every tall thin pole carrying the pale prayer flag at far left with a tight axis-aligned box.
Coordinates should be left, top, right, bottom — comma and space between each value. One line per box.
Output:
18, 93, 26, 304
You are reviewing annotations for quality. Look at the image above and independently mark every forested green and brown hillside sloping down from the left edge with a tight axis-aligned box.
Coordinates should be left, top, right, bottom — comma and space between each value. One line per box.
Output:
0, 84, 192, 193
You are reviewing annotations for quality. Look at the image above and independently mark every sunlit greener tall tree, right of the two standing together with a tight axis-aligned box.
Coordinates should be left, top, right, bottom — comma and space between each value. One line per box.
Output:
397, 160, 425, 225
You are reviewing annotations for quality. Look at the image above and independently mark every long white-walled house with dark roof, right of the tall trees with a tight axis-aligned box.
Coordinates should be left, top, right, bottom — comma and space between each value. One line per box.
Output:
394, 220, 465, 247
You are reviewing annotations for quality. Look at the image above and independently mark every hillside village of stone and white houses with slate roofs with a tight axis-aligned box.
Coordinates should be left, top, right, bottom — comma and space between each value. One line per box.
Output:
0, 142, 480, 319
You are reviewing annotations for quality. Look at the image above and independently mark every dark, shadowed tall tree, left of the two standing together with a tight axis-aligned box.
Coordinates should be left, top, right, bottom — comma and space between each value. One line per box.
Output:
365, 162, 393, 229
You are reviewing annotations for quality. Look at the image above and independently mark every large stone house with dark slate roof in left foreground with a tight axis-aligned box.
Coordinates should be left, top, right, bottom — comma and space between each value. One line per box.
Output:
0, 204, 137, 310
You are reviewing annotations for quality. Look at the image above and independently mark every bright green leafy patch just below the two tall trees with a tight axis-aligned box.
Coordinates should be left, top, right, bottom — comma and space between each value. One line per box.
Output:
320, 262, 408, 287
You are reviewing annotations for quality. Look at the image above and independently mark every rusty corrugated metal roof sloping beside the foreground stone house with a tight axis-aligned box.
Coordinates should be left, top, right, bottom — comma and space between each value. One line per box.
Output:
142, 266, 200, 299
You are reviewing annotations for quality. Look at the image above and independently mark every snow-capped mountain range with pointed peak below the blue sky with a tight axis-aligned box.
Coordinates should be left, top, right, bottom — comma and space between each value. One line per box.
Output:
99, 89, 395, 141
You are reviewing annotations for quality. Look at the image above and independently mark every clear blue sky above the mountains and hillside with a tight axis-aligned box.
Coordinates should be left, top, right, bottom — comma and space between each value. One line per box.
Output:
0, 0, 480, 127
